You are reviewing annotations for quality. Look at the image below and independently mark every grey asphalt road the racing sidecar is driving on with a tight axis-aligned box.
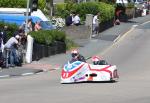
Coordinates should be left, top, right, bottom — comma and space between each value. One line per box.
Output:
0, 19, 150, 103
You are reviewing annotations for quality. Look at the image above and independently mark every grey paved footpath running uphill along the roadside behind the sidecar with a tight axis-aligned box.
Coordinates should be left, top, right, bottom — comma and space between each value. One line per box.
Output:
0, 15, 150, 77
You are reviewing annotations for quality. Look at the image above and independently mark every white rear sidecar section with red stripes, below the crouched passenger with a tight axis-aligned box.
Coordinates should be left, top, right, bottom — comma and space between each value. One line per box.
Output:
85, 64, 119, 81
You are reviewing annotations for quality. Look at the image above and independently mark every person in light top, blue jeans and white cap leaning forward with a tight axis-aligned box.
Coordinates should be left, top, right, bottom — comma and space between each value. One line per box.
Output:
4, 35, 20, 67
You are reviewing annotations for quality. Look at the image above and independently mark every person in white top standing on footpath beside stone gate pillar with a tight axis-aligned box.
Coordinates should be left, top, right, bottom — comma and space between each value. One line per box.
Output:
92, 12, 100, 37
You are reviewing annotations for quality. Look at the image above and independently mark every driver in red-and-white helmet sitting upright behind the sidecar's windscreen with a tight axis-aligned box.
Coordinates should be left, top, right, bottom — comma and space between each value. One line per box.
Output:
71, 50, 86, 62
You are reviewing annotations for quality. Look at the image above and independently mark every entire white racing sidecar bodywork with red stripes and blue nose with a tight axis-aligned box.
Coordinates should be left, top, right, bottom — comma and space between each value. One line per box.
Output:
61, 61, 118, 83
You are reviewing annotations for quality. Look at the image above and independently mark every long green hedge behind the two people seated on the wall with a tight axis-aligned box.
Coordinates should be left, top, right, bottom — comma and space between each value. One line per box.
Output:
55, 2, 115, 22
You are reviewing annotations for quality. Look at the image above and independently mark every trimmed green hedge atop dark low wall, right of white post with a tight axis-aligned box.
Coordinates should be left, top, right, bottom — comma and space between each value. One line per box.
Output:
29, 30, 66, 45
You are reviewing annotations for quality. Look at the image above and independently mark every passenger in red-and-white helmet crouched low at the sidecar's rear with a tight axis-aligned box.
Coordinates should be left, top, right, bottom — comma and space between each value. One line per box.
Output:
92, 56, 108, 65
